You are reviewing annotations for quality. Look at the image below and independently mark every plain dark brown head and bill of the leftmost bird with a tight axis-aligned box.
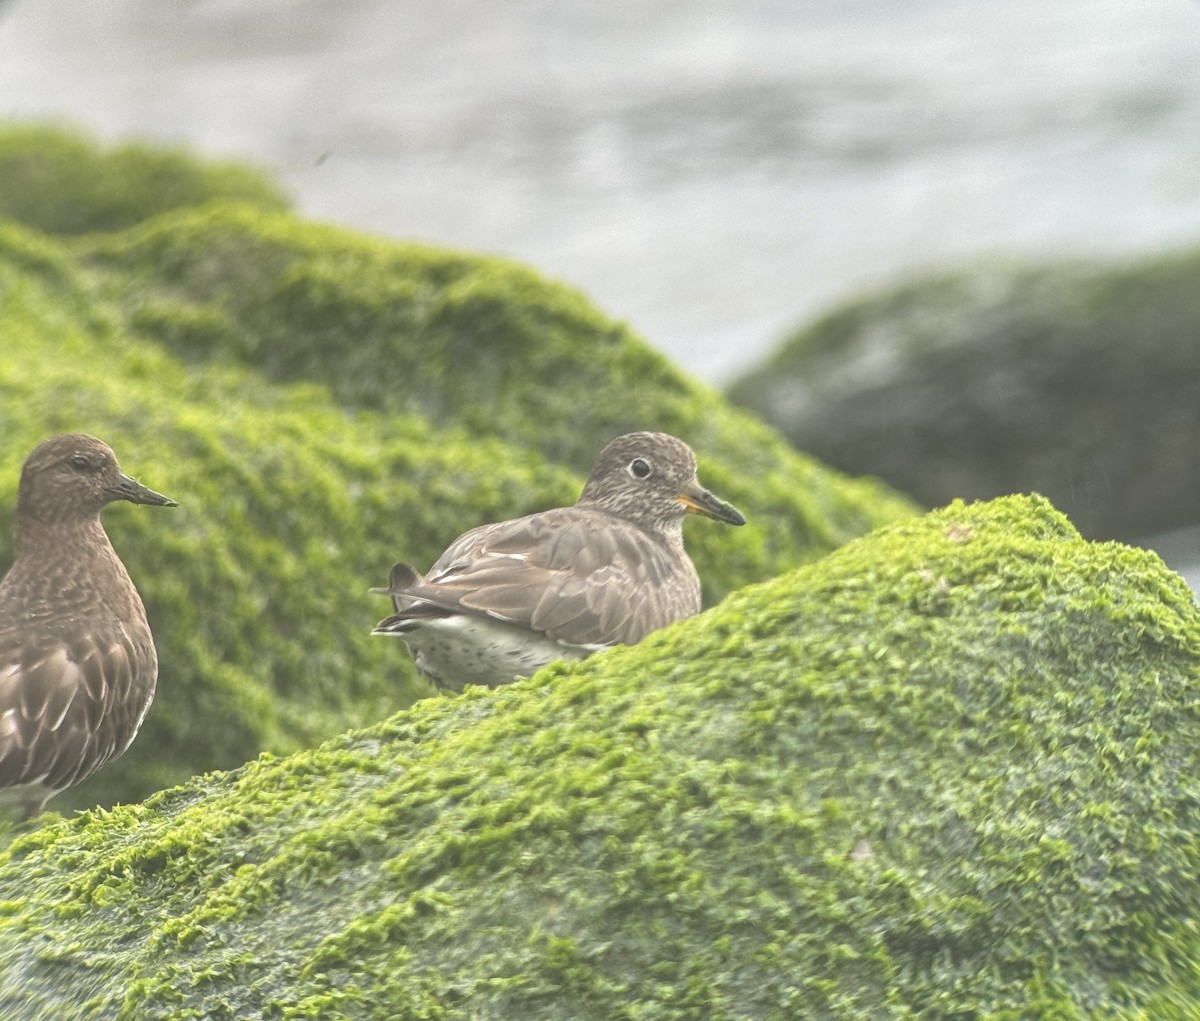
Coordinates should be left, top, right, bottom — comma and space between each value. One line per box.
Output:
17, 433, 176, 523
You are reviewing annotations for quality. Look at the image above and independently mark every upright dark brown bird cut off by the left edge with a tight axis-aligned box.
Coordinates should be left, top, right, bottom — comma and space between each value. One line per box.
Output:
0, 433, 175, 818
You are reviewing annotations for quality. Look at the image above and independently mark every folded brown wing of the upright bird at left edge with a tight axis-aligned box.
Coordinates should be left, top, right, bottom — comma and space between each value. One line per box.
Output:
0, 621, 157, 791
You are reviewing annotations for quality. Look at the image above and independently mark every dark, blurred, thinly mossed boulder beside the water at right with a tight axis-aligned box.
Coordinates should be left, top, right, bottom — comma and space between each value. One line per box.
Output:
730, 257, 1200, 539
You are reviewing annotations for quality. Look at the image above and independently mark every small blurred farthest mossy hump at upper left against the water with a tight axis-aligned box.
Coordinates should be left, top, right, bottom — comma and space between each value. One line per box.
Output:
0, 124, 288, 235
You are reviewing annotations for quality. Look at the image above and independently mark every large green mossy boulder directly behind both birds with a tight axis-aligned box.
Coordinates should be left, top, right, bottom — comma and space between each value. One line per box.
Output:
0, 125, 911, 811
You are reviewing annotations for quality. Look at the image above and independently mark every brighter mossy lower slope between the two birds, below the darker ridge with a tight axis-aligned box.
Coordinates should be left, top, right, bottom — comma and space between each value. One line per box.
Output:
0, 229, 578, 810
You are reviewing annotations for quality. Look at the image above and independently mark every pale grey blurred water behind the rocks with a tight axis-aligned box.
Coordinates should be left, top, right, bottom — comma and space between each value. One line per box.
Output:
0, 0, 1200, 383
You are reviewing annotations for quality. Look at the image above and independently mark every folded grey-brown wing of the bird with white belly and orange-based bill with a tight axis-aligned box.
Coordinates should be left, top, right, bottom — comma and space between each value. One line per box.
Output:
380, 508, 700, 647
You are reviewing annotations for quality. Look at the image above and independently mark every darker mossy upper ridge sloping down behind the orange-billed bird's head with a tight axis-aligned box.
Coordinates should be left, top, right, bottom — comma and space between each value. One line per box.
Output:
72, 206, 911, 583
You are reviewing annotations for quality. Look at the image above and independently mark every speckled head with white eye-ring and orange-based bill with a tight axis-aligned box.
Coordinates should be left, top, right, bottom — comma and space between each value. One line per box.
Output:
578, 432, 745, 531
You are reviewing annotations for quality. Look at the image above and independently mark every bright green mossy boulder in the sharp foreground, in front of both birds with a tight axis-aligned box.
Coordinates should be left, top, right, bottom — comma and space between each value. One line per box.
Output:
0, 498, 1200, 1021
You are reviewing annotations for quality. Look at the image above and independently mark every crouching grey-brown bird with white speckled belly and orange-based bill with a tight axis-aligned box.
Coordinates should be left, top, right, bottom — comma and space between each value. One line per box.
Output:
372, 432, 745, 691
